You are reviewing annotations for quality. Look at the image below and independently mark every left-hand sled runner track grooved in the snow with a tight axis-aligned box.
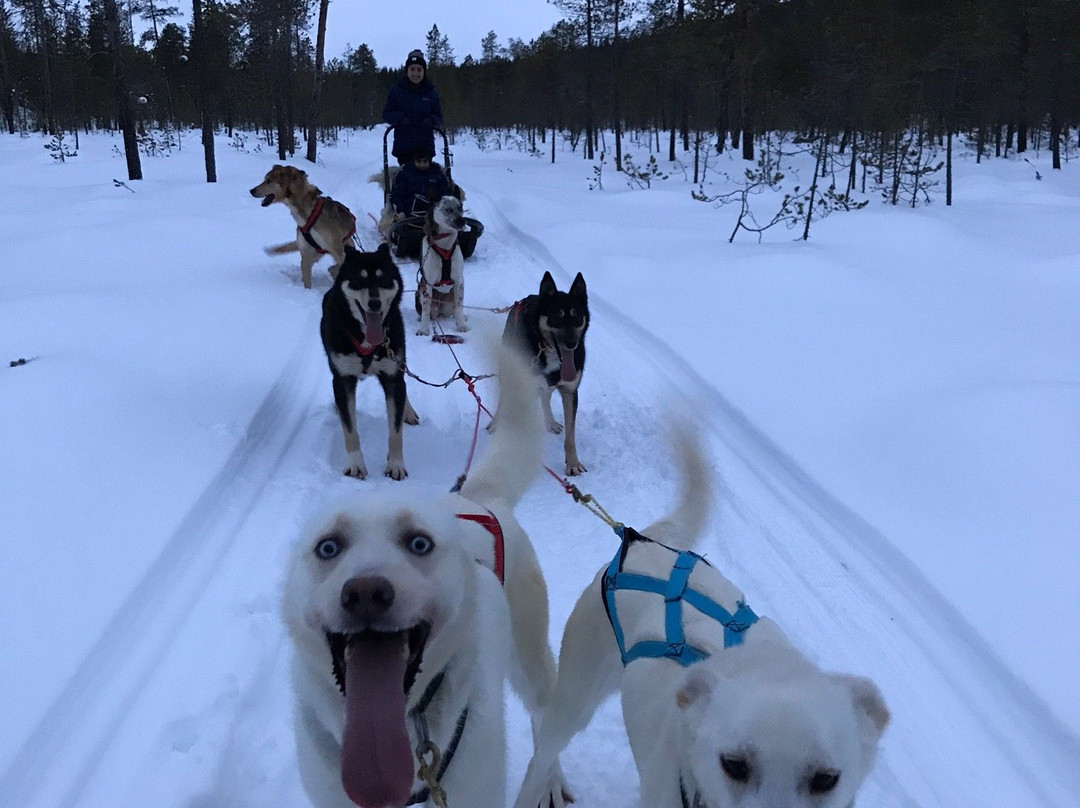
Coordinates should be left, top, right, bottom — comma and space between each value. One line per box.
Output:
0, 317, 324, 808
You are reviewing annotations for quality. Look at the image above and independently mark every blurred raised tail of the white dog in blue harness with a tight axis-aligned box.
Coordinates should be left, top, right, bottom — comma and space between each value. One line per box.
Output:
642, 423, 716, 550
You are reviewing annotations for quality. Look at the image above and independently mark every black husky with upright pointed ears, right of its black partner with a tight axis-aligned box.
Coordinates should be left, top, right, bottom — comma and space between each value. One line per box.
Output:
492, 272, 589, 476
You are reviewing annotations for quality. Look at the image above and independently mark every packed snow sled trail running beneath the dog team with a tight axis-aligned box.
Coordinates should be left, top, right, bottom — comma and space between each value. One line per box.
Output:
0, 165, 1080, 808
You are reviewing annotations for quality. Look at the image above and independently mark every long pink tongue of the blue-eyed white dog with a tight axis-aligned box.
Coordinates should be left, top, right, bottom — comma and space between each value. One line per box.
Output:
341, 635, 413, 808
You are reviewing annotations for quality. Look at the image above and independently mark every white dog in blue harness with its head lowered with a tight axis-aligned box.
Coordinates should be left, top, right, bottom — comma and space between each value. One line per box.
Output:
515, 436, 889, 808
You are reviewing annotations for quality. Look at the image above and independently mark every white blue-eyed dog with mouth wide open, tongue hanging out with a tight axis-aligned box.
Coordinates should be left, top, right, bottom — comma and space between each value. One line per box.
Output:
282, 351, 564, 808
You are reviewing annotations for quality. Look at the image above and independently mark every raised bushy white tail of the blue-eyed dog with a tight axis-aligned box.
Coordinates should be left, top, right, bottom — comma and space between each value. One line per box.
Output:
461, 345, 543, 507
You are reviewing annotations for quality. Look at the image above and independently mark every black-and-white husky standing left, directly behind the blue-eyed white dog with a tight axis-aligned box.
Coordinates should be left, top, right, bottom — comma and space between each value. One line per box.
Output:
320, 244, 419, 480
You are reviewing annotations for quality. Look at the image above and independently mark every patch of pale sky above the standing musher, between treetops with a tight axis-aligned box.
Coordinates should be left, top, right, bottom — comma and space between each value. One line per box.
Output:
326, 0, 563, 67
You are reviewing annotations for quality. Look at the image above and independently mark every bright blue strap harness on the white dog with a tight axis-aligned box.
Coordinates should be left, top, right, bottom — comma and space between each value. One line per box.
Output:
600, 526, 757, 666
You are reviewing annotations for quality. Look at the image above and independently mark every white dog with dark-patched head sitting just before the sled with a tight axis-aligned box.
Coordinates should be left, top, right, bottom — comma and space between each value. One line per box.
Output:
416, 196, 469, 337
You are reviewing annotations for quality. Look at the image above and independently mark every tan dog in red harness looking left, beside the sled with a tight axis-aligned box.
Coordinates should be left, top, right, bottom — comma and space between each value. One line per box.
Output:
252, 165, 356, 288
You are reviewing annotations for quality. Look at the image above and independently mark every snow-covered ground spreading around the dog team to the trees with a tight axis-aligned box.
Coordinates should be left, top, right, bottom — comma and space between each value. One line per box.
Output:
0, 132, 1080, 808
